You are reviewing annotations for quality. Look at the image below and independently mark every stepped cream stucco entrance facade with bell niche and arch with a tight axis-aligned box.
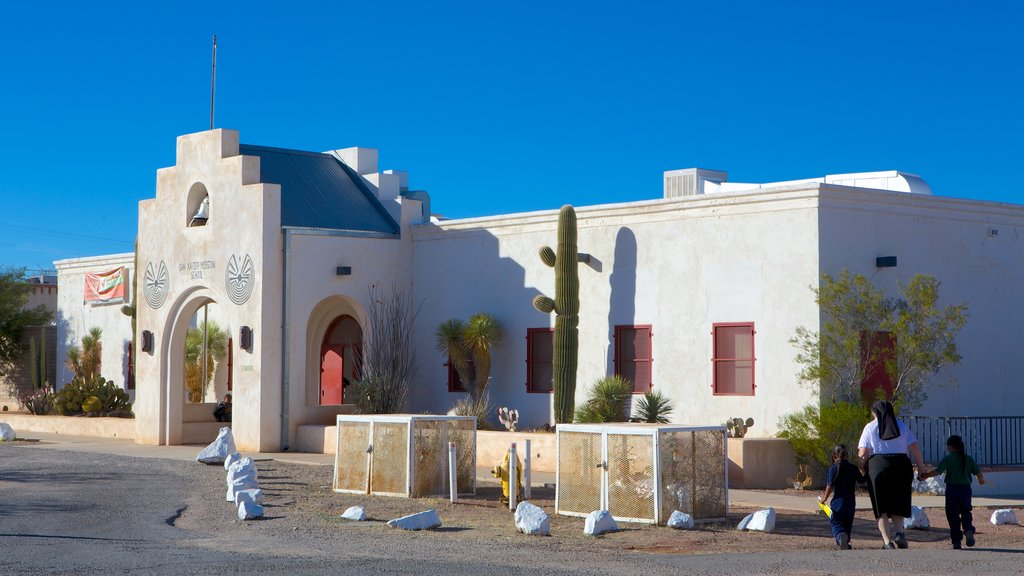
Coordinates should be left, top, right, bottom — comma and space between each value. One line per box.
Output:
135, 130, 282, 451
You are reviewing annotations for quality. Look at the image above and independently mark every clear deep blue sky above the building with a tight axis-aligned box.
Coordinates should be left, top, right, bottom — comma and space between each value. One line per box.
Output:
0, 0, 1024, 269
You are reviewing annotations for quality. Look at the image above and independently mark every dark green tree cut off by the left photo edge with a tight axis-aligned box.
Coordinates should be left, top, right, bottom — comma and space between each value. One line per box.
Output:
0, 266, 53, 374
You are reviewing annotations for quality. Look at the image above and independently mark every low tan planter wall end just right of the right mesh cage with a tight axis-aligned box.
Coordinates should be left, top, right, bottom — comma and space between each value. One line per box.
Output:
728, 438, 798, 489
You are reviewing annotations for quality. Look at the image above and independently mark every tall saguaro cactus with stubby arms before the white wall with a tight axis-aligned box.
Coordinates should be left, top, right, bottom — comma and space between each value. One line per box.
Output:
534, 205, 580, 423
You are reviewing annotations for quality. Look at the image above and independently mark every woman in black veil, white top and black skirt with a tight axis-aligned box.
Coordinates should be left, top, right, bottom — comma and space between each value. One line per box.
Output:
857, 400, 925, 548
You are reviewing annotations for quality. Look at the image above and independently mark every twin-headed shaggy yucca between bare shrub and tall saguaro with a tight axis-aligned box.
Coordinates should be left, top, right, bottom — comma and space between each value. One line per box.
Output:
434, 313, 503, 403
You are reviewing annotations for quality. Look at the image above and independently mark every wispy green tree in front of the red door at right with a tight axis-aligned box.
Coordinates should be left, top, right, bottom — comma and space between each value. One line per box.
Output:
790, 271, 967, 410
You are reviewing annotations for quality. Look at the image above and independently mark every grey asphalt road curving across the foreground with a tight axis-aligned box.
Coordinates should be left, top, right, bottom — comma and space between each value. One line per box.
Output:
0, 445, 1024, 576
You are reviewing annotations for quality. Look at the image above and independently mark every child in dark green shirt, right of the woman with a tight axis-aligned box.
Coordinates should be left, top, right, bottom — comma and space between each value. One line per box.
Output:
918, 435, 985, 550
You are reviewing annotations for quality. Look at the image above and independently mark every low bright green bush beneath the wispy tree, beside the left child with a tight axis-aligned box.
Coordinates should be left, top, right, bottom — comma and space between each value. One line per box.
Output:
778, 402, 871, 471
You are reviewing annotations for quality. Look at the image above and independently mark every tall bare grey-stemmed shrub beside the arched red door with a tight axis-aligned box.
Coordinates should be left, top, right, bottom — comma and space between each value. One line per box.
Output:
353, 285, 420, 414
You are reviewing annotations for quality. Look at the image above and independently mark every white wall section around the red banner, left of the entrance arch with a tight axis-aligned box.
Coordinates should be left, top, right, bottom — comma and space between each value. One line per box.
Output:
54, 253, 135, 389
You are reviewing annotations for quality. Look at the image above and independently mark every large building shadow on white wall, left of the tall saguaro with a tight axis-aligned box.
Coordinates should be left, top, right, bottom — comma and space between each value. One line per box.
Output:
412, 224, 556, 428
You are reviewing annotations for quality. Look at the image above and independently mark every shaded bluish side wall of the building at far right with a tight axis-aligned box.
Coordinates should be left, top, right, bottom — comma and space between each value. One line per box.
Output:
821, 187, 1024, 416
